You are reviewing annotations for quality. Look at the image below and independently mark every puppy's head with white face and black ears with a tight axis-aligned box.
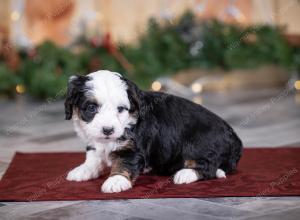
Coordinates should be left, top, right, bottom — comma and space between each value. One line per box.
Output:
65, 70, 141, 141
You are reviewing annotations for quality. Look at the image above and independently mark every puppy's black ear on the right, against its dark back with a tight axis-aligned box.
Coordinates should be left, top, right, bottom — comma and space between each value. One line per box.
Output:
123, 78, 143, 113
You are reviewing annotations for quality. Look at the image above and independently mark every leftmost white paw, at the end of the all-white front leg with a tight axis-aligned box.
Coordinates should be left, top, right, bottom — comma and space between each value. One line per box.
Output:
67, 164, 99, 182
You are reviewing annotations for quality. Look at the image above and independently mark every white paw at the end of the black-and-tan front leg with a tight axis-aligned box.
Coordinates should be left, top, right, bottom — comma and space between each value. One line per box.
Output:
101, 175, 132, 193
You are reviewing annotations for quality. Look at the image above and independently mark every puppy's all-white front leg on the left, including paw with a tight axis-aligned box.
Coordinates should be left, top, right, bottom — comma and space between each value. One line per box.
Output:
67, 146, 103, 182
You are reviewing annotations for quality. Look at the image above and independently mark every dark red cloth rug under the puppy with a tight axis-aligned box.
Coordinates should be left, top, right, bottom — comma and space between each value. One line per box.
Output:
0, 148, 300, 201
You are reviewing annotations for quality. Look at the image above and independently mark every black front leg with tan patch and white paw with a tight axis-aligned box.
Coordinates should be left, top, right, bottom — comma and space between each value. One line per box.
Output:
101, 149, 143, 193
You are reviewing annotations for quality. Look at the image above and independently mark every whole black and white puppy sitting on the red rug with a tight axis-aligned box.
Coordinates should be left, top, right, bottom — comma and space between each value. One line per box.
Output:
65, 70, 242, 193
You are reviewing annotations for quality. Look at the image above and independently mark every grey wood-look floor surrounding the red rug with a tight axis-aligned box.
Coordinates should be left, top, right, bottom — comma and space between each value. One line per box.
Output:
0, 88, 300, 220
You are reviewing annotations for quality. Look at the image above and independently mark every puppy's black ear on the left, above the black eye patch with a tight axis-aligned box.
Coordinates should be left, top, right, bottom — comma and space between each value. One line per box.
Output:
65, 75, 89, 120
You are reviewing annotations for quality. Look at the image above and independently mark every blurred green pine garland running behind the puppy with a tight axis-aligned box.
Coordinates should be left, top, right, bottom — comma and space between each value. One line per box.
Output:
0, 12, 300, 99
